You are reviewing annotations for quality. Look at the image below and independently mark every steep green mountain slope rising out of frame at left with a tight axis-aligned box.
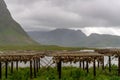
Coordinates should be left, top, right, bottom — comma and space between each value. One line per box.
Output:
0, 0, 34, 45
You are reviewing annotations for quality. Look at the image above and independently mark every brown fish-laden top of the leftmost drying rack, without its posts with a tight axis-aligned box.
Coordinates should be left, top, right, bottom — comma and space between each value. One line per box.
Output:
0, 51, 44, 62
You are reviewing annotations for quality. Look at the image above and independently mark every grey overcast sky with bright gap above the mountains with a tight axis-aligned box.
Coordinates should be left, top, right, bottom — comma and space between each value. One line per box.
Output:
5, 0, 120, 35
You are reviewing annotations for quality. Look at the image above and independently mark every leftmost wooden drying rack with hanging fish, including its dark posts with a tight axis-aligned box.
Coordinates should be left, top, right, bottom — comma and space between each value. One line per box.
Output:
0, 51, 44, 79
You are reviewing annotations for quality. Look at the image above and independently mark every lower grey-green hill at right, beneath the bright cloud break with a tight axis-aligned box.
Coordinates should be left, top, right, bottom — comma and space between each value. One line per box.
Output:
88, 34, 120, 47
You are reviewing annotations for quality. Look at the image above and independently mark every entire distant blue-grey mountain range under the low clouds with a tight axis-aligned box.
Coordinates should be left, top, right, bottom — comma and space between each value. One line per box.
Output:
28, 29, 120, 47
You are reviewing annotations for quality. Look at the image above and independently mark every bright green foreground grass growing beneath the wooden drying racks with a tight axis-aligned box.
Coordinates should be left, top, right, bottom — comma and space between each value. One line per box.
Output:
2, 66, 120, 80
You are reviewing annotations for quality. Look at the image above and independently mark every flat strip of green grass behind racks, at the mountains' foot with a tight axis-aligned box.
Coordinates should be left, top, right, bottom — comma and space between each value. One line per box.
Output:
0, 45, 89, 51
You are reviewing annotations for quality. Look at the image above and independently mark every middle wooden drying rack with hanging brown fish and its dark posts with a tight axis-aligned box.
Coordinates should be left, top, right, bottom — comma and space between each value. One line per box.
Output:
47, 51, 104, 79
